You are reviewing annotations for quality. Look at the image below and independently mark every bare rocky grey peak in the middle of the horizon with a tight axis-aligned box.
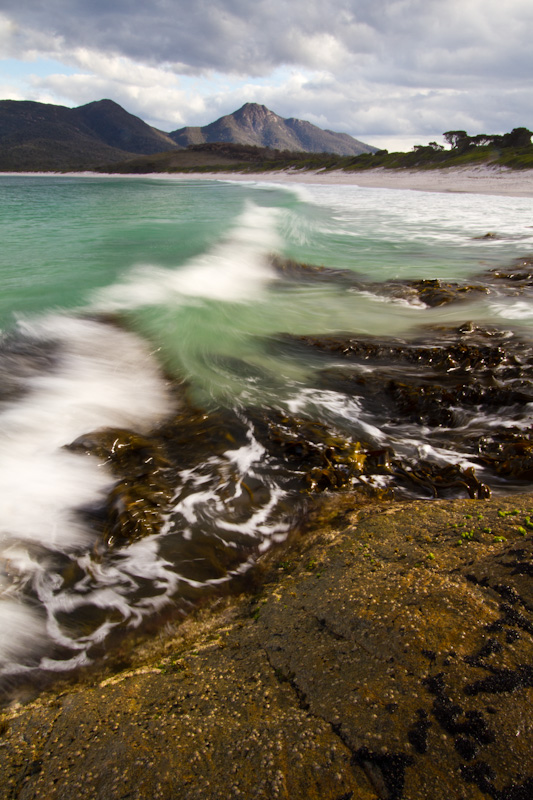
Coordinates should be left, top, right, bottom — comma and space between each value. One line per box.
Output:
169, 103, 377, 156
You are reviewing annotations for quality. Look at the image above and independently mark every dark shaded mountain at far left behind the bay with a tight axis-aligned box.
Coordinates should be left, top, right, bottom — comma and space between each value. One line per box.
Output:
0, 100, 178, 171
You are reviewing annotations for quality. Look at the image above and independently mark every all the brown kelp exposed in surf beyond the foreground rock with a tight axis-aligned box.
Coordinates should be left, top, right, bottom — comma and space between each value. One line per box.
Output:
64, 250, 533, 552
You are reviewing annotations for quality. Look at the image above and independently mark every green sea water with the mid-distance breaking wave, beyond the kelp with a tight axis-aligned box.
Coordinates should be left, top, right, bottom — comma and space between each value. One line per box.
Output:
0, 176, 533, 398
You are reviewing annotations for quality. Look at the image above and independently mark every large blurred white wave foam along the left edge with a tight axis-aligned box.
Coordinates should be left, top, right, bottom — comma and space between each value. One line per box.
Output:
0, 316, 171, 665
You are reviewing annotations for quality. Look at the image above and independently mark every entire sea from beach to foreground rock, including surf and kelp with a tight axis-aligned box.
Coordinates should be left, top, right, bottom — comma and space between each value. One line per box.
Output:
0, 175, 533, 684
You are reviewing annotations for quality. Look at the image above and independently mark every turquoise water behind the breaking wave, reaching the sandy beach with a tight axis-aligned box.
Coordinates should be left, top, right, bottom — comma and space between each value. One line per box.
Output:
0, 176, 533, 326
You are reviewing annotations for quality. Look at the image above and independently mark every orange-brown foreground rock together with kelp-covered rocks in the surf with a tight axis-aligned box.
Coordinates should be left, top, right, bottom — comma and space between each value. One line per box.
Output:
0, 257, 533, 800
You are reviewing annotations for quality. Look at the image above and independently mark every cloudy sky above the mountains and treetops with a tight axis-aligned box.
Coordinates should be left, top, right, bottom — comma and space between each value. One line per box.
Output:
0, 0, 533, 150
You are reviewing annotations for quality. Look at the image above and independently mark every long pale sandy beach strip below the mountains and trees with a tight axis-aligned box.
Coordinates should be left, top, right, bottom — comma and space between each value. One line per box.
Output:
4, 165, 533, 197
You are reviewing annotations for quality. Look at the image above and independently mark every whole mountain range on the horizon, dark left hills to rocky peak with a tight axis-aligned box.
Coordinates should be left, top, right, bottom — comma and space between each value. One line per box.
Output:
0, 99, 376, 172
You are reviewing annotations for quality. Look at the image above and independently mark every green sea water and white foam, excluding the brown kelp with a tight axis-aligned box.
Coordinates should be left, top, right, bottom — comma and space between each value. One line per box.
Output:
0, 176, 533, 674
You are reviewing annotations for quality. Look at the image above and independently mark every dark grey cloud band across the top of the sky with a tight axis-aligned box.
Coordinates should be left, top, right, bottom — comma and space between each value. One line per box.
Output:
2, 0, 533, 75
